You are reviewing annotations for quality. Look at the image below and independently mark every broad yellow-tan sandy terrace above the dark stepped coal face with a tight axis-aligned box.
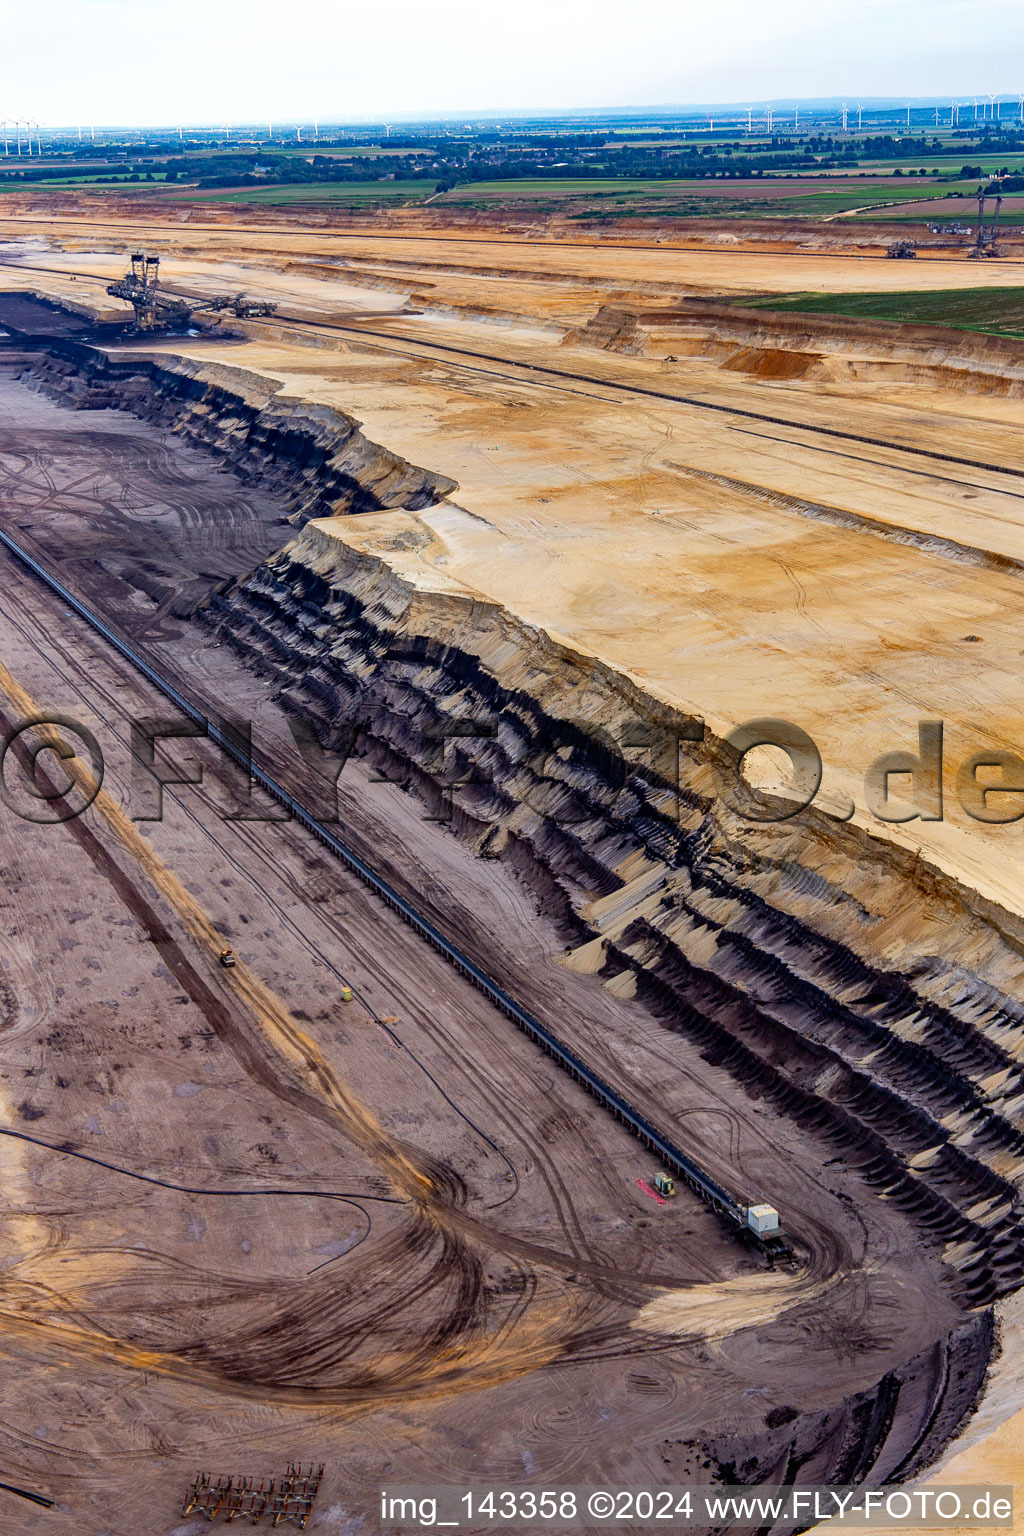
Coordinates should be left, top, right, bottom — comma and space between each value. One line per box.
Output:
30, 258, 1024, 911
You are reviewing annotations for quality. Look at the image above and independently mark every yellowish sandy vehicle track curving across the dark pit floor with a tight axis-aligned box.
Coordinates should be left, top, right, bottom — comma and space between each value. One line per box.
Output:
0, 648, 706, 1404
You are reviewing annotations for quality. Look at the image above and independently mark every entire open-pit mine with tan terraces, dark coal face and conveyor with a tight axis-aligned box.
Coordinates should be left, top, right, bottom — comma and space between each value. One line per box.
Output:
0, 197, 1024, 1536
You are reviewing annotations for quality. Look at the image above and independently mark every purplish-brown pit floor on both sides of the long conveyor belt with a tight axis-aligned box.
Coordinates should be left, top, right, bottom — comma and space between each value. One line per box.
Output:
0, 365, 982, 1536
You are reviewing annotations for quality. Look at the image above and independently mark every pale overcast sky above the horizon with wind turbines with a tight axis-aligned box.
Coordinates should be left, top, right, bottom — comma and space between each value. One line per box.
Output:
8, 0, 1024, 124
